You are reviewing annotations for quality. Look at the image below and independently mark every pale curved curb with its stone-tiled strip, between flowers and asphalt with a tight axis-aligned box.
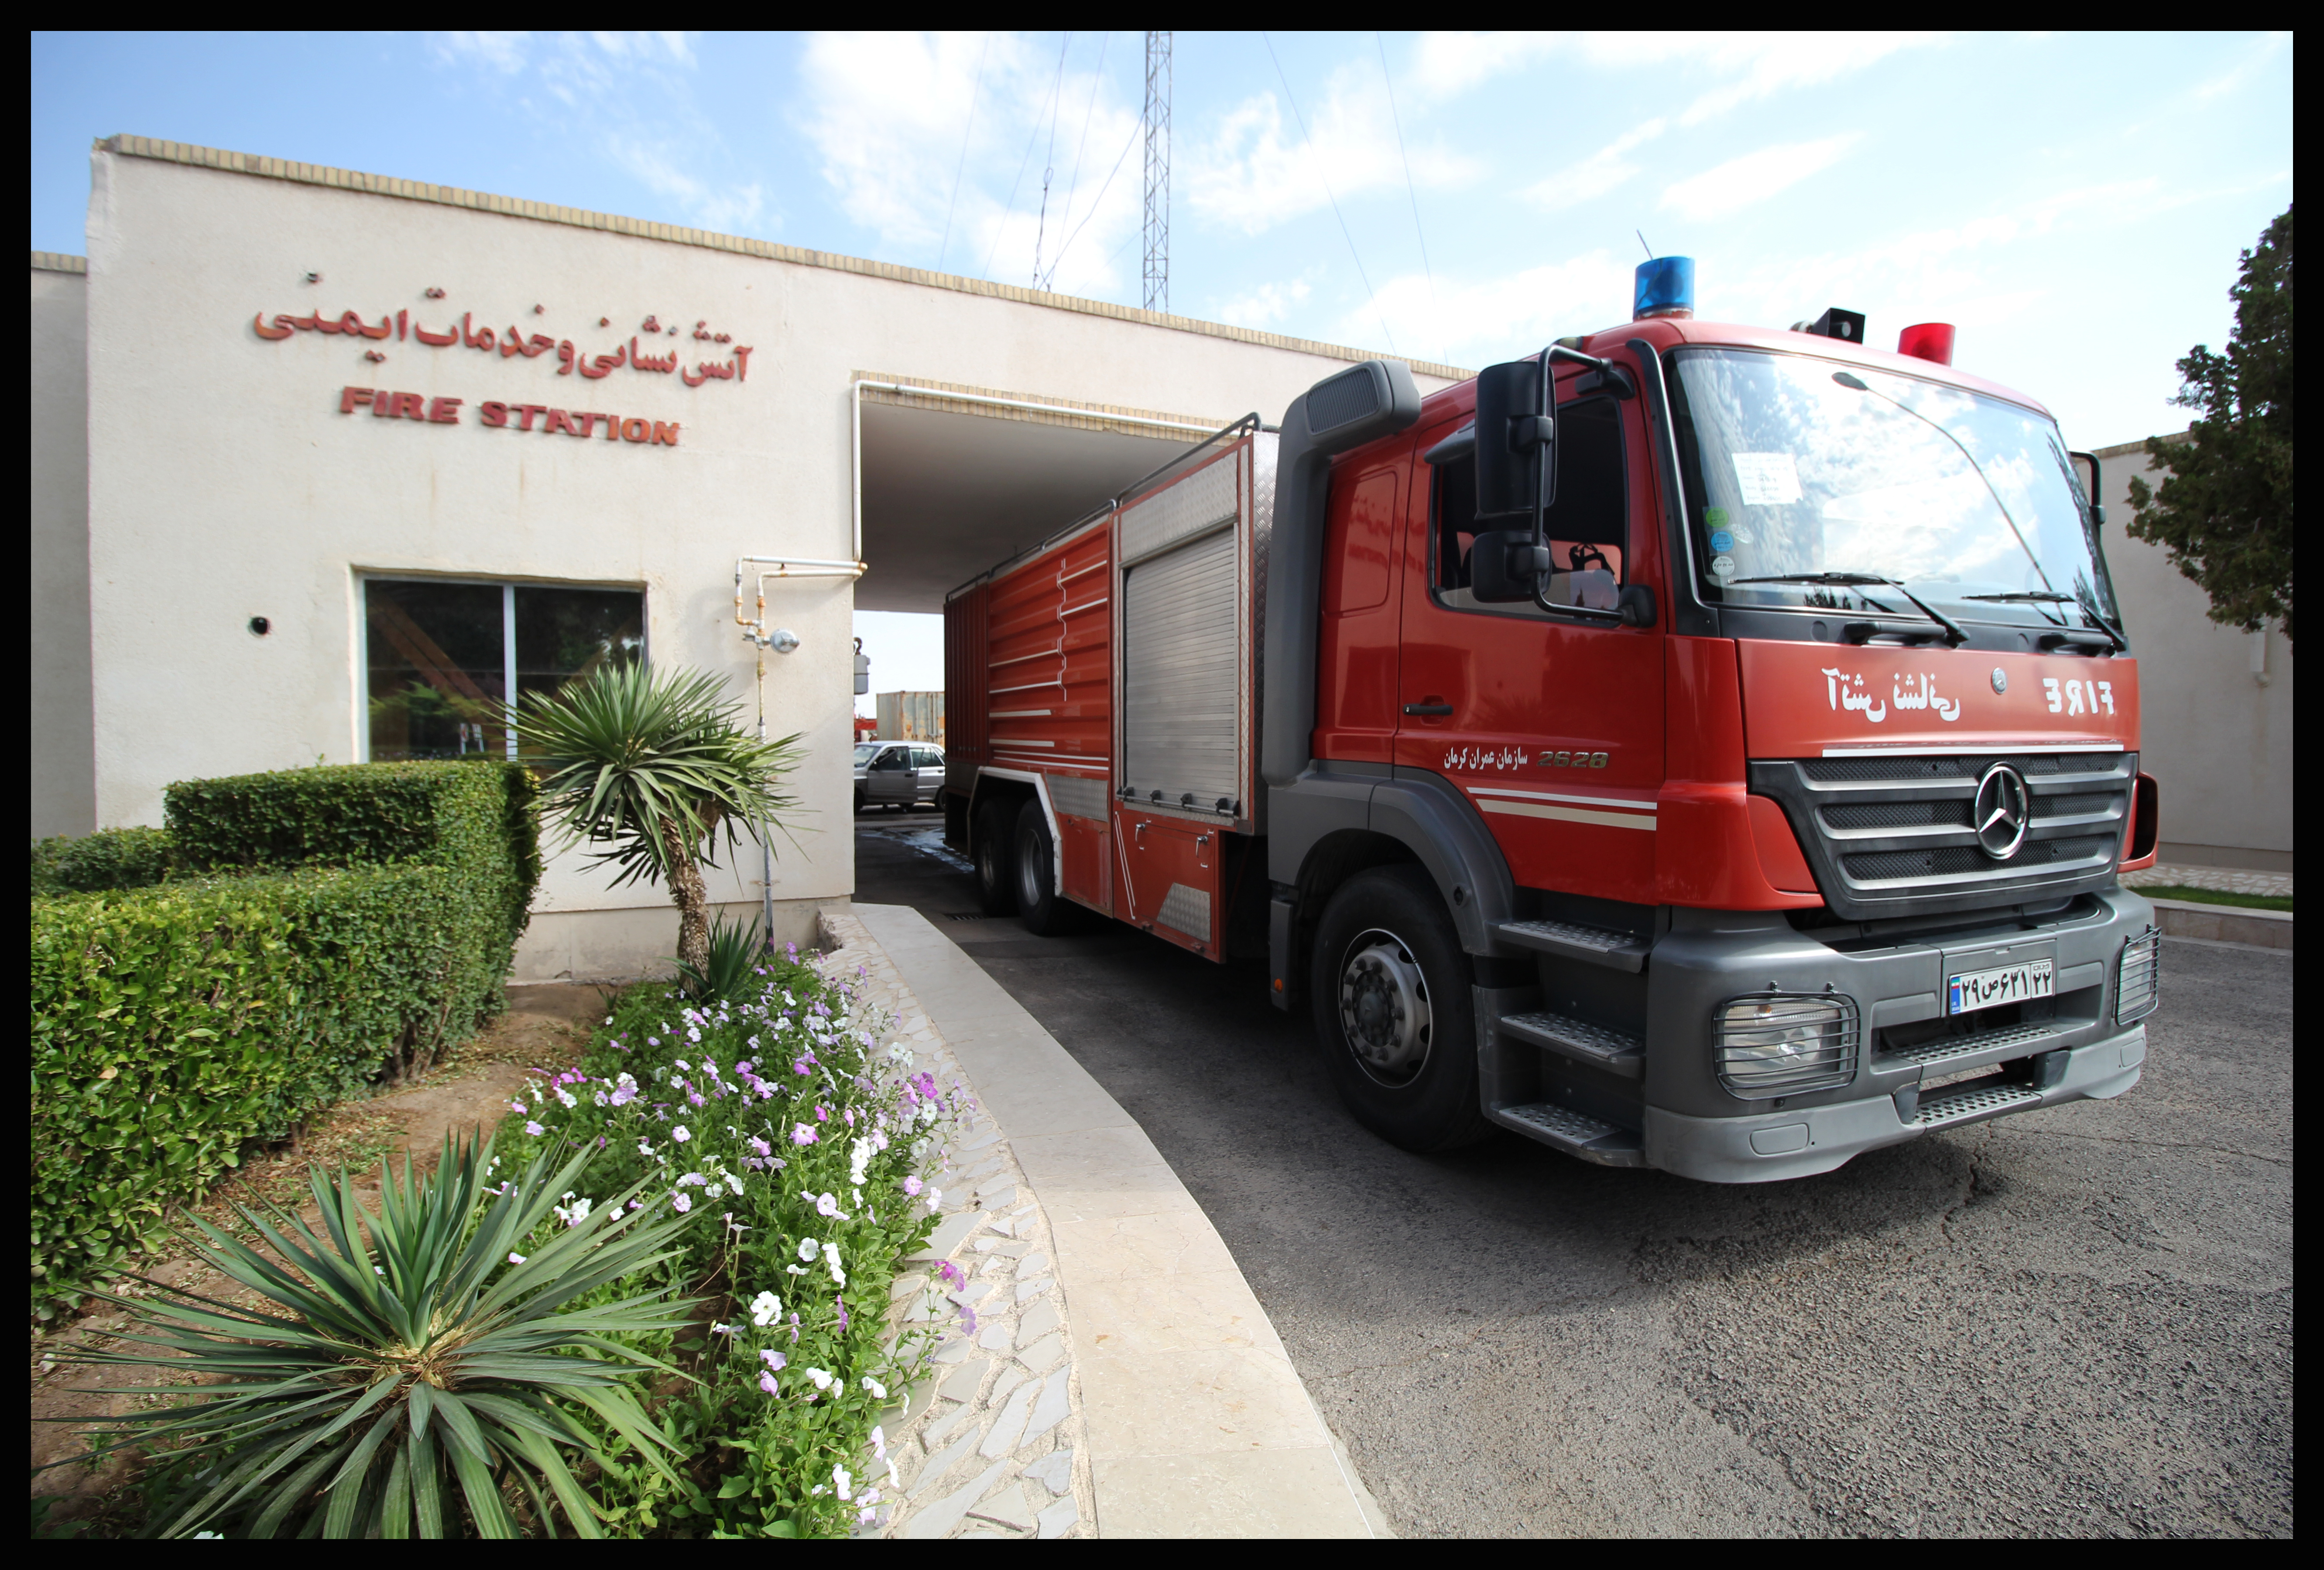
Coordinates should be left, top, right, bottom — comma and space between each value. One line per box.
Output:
825, 903, 1388, 1537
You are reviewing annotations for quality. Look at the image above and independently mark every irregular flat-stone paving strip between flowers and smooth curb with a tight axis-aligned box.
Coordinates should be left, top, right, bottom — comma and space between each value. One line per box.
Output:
823, 913, 1097, 1540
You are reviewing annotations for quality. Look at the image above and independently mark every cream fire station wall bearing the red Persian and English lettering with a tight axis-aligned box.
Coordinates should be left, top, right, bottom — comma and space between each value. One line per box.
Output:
63, 144, 1446, 980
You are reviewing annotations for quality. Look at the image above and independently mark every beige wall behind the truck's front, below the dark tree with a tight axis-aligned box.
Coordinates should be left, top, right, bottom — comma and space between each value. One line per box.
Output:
2096, 441, 2291, 873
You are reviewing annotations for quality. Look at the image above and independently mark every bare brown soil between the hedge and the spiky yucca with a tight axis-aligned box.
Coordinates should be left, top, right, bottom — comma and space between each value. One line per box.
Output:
30, 982, 607, 1535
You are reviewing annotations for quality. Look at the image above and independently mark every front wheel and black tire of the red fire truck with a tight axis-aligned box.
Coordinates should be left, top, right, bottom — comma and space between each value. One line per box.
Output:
1309, 866, 1492, 1152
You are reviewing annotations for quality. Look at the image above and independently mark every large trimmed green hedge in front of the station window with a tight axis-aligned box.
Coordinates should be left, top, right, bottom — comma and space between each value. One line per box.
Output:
30, 764, 539, 1312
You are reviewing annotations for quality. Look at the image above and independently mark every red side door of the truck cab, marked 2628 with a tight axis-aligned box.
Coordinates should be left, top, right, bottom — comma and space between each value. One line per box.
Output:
1395, 371, 1664, 903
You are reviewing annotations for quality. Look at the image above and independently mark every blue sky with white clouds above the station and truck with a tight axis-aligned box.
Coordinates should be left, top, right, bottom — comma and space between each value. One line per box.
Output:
30, 33, 2291, 690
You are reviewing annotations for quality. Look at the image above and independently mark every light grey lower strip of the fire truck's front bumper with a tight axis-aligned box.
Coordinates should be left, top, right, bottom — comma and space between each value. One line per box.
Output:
1645, 1024, 2147, 1182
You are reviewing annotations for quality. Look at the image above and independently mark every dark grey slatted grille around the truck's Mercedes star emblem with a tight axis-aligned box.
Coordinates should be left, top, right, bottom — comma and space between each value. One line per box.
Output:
1750, 752, 2138, 920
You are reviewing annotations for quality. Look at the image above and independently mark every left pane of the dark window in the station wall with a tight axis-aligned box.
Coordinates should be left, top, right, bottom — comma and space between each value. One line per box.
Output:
363, 581, 509, 762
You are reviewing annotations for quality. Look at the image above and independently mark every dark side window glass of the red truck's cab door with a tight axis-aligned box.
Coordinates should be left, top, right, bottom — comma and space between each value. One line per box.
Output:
1432, 397, 1629, 615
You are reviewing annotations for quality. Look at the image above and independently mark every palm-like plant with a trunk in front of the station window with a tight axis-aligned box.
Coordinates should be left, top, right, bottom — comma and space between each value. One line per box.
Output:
509, 664, 799, 973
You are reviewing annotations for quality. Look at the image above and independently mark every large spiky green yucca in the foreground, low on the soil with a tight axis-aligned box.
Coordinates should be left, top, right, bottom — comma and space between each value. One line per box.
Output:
86, 1136, 690, 1537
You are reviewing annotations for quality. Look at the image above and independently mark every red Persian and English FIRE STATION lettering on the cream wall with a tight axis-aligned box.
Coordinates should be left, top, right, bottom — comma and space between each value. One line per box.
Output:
251, 290, 751, 446
